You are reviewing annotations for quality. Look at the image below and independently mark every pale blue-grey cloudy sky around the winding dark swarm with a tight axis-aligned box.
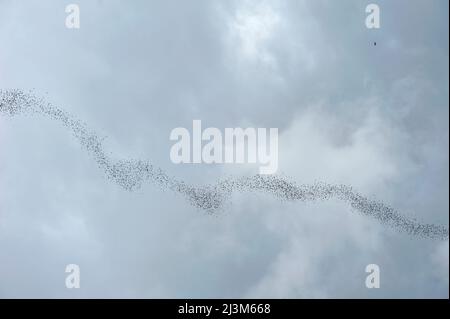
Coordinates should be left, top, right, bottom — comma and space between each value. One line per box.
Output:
0, 0, 449, 298
